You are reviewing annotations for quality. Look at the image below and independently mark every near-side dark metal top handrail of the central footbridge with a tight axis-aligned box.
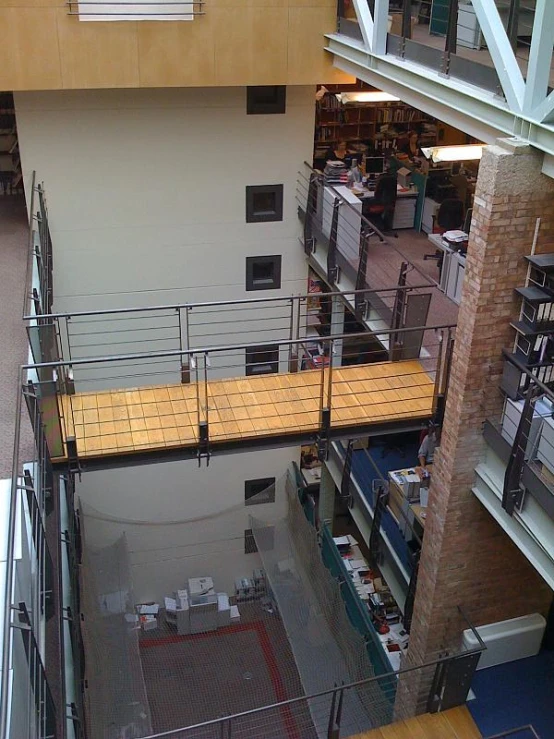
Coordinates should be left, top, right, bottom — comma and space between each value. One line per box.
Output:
23, 323, 456, 370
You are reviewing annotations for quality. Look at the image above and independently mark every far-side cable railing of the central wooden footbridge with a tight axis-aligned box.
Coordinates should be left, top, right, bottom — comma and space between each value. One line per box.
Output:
26, 283, 442, 370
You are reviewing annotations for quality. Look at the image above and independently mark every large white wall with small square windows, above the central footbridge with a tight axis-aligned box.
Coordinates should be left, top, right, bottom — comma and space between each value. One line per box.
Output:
16, 87, 315, 389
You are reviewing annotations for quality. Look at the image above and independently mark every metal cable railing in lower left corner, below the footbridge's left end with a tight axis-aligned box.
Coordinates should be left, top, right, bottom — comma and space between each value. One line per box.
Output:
0, 370, 69, 739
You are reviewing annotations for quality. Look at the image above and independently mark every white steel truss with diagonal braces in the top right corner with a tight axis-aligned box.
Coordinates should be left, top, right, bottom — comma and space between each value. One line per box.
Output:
326, 0, 554, 164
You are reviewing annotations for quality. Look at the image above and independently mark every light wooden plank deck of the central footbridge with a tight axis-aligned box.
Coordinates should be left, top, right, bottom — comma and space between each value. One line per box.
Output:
54, 360, 434, 461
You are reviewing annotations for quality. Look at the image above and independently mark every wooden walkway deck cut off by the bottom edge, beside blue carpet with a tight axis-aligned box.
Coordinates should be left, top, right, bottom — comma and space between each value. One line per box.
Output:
350, 706, 481, 739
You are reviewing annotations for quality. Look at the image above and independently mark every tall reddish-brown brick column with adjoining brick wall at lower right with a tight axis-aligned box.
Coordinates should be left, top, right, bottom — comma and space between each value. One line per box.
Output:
397, 139, 554, 716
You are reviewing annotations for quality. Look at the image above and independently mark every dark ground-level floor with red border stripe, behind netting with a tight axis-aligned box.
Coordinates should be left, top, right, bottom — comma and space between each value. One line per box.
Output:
140, 602, 317, 739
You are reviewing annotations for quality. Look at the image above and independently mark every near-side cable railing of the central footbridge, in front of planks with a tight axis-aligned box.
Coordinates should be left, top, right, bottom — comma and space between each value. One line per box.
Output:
21, 324, 453, 468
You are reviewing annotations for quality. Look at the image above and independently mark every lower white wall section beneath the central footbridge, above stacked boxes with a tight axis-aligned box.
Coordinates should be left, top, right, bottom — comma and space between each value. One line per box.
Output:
77, 447, 300, 601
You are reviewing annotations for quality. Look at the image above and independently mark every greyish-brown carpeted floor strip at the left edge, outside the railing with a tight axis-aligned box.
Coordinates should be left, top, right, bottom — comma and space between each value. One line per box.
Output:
0, 196, 32, 479
